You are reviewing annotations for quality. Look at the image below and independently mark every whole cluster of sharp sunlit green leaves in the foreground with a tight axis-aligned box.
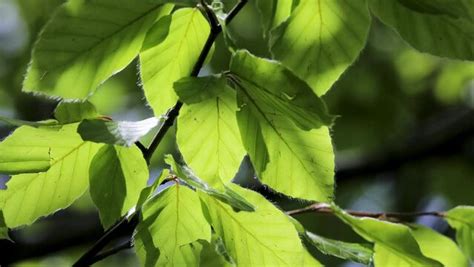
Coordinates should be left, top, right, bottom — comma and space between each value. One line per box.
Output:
0, 0, 474, 266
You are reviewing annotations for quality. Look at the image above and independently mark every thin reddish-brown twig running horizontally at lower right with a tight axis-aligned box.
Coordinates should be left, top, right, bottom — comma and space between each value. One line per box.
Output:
286, 203, 445, 219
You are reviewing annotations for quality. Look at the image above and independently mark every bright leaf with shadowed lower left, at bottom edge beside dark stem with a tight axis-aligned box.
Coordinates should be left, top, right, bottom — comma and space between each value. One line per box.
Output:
134, 184, 211, 266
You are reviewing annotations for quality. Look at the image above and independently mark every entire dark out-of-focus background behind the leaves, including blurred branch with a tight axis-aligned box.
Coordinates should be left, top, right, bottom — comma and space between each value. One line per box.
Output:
0, 0, 474, 266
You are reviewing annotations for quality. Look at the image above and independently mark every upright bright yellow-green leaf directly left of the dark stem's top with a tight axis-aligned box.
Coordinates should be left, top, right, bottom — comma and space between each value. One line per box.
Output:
140, 8, 210, 115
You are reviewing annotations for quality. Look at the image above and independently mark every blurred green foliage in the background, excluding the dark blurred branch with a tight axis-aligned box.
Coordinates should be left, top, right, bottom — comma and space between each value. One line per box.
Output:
0, 0, 474, 266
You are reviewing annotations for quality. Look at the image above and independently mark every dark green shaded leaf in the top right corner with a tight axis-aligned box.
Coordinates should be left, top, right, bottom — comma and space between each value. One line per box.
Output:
370, 0, 474, 60
